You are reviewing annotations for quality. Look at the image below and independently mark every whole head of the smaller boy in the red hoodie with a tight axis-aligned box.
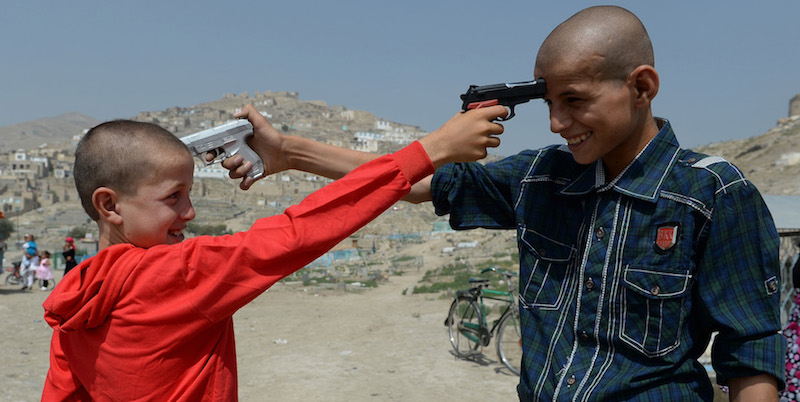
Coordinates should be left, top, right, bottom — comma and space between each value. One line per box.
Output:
74, 120, 195, 249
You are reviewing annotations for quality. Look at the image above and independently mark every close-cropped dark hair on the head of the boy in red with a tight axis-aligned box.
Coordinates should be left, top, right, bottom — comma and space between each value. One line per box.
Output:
74, 120, 191, 221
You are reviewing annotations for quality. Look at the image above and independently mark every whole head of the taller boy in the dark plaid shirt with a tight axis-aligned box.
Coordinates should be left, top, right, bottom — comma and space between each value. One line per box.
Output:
534, 6, 658, 178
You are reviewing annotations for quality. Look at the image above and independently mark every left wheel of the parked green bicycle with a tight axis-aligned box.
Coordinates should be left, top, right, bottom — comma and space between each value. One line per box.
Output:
447, 295, 481, 357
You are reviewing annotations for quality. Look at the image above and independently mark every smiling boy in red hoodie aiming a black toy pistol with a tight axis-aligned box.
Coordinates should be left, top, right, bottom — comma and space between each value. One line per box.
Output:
42, 106, 506, 401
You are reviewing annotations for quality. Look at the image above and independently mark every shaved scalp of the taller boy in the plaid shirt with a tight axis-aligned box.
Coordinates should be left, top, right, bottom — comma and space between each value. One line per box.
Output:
536, 6, 655, 79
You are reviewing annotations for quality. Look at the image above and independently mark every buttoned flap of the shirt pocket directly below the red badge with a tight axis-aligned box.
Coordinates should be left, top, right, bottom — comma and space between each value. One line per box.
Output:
624, 267, 692, 299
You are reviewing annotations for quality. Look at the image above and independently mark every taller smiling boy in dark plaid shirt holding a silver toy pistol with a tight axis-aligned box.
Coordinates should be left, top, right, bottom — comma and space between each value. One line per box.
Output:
223, 6, 786, 401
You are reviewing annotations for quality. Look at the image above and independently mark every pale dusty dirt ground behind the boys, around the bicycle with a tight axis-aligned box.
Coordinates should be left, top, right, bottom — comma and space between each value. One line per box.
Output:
0, 262, 518, 401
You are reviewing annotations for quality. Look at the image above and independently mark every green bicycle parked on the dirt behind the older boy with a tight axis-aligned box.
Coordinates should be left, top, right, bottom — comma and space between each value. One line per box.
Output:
444, 267, 522, 375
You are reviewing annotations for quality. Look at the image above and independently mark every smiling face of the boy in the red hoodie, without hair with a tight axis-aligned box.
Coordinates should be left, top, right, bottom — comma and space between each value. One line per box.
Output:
110, 151, 195, 248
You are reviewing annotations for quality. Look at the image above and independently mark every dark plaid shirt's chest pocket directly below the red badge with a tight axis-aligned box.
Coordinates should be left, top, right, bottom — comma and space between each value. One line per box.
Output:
620, 266, 692, 357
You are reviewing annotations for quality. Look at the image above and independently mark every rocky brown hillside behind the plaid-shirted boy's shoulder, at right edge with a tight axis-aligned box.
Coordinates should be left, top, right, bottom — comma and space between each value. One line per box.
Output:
694, 115, 800, 195
